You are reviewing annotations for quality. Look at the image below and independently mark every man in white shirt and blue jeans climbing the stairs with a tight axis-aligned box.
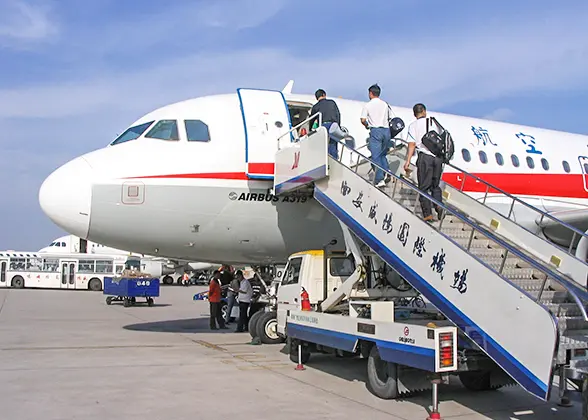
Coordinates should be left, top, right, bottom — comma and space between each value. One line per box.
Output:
361, 85, 391, 188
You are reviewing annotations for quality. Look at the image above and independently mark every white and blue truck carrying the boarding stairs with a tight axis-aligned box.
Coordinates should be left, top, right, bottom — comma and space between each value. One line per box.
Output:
267, 243, 515, 405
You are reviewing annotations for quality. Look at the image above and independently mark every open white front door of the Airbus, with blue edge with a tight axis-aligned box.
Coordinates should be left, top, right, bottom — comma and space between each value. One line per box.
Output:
237, 89, 291, 179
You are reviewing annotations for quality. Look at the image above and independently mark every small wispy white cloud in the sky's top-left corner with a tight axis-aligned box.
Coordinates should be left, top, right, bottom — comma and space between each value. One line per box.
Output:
0, 0, 59, 47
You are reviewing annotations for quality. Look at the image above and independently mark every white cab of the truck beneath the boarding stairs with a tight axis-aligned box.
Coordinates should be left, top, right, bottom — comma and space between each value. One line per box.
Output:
277, 250, 355, 337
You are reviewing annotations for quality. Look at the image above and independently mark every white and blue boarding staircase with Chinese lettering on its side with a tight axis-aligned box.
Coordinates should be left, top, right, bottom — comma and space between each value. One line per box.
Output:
274, 127, 588, 400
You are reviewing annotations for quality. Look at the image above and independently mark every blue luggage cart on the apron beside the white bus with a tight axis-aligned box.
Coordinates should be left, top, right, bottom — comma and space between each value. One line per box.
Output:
103, 277, 159, 307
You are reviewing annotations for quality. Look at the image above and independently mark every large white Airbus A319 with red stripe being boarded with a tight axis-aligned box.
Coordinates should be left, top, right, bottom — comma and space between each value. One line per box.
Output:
39, 82, 588, 264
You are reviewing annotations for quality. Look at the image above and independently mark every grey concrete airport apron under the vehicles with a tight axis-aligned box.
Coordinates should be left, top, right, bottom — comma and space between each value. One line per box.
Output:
0, 286, 581, 420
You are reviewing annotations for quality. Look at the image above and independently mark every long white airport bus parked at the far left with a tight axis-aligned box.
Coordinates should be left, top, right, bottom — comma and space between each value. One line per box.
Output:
0, 251, 126, 291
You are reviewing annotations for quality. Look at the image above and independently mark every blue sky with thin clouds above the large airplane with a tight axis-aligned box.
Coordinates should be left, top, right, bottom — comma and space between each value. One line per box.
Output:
0, 0, 588, 250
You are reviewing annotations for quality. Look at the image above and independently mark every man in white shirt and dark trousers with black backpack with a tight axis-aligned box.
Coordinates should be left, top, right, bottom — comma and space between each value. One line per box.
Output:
404, 104, 443, 222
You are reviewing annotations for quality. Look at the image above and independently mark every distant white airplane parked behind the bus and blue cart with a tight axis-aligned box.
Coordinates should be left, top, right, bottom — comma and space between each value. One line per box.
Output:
38, 235, 221, 284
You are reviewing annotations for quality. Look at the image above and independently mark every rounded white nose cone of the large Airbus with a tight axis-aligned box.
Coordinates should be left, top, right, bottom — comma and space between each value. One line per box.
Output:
39, 157, 92, 238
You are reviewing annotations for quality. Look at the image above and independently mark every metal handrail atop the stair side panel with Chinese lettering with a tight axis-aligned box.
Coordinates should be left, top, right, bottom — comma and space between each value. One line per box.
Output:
329, 140, 588, 321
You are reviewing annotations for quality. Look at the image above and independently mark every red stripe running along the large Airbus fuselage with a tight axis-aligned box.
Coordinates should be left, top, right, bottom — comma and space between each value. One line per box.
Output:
120, 171, 588, 198
